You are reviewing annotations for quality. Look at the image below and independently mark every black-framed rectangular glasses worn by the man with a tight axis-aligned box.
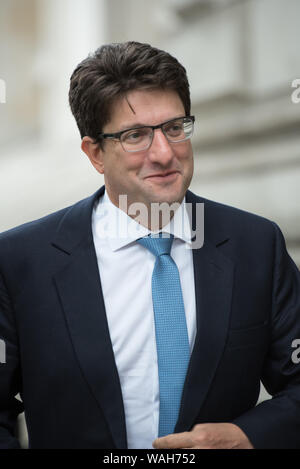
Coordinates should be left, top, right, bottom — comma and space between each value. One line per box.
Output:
98, 116, 195, 153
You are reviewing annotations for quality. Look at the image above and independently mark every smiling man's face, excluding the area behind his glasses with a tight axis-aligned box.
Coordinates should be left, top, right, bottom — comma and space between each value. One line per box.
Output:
88, 90, 193, 208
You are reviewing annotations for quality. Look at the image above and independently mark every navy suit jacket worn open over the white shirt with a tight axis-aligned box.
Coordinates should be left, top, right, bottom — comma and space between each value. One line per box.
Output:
0, 187, 300, 448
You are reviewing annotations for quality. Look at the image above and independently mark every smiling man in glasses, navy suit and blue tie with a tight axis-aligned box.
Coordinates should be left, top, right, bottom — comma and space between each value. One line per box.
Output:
0, 42, 300, 449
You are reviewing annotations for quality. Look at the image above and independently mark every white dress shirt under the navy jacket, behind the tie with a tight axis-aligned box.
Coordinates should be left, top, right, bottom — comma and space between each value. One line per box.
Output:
92, 192, 196, 448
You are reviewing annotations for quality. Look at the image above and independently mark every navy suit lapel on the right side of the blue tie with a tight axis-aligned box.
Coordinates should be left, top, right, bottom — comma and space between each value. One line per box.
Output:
175, 191, 234, 432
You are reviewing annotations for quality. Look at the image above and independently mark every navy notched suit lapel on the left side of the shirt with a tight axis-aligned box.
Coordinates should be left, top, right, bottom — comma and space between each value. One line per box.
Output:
53, 189, 127, 448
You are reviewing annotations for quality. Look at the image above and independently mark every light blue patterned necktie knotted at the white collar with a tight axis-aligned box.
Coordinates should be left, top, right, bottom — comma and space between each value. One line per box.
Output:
137, 233, 190, 436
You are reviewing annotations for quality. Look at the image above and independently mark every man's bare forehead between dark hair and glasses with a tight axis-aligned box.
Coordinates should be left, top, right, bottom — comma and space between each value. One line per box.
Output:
104, 89, 185, 132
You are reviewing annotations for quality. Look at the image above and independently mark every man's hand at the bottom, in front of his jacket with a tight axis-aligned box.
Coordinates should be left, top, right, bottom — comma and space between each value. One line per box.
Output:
152, 423, 253, 449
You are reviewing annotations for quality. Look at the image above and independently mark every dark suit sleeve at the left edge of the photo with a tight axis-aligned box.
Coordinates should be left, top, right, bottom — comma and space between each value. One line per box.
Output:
0, 273, 23, 449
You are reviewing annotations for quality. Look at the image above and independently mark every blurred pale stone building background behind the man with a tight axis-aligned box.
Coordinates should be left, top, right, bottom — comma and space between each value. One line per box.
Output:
0, 0, 300, 446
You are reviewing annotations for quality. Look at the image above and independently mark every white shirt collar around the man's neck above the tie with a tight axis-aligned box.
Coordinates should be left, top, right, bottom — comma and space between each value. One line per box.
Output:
93, 191, 192, 251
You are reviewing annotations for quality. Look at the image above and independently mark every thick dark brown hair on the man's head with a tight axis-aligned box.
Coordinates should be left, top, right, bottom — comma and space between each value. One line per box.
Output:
69, 41, 191, 144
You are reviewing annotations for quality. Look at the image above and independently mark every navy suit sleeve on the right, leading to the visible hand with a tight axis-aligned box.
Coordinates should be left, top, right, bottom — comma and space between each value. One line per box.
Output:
232, 224, 300, 449
